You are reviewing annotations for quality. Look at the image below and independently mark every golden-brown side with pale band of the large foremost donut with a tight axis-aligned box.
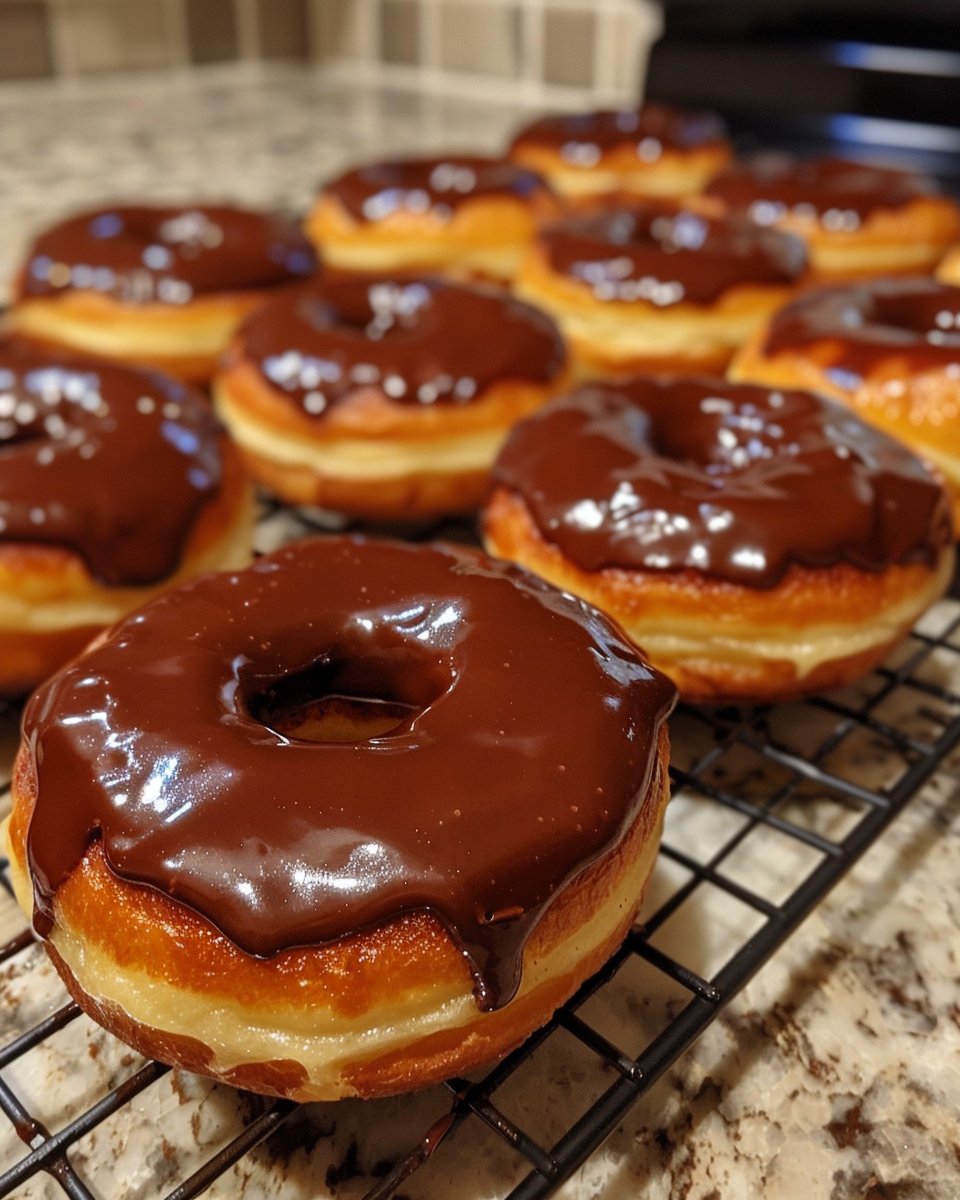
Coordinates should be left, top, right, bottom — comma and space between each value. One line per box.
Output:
5, 728, 670, 1100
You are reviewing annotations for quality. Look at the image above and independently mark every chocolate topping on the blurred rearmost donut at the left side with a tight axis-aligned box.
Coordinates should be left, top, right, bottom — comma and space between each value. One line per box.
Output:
19, 205, 317, 305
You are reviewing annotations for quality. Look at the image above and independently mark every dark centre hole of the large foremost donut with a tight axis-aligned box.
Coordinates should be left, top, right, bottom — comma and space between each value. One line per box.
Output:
253, 656, 449, 742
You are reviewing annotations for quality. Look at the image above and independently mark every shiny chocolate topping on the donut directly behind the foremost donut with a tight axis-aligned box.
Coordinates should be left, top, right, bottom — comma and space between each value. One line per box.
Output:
239, 280, 564, 416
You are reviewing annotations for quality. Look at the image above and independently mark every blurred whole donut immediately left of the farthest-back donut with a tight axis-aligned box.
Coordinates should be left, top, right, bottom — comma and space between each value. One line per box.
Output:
306, 155, 559, 280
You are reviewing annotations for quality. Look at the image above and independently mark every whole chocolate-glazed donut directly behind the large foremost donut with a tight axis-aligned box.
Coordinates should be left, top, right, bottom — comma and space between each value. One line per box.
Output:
214, 280, 565, 520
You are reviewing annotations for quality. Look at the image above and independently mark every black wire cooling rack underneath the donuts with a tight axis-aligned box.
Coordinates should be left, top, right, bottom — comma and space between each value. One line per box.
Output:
0, 506, 960, 1200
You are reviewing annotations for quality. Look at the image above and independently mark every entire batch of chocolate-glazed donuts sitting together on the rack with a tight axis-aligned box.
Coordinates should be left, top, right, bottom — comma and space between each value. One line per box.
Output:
0, 96, 960, 1099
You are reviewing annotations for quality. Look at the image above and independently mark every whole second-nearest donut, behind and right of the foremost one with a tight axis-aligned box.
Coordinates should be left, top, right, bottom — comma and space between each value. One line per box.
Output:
484, 379, 953, 702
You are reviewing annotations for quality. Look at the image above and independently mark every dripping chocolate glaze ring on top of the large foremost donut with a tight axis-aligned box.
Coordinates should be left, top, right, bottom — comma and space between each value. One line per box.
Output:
24, 538, 674, 1008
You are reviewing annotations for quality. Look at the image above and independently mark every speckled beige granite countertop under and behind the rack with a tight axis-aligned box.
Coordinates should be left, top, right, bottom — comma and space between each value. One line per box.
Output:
0, 67, 960, 1200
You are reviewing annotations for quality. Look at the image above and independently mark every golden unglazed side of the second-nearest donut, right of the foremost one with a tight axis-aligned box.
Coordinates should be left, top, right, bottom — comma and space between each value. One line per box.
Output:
484, 488, 954, 704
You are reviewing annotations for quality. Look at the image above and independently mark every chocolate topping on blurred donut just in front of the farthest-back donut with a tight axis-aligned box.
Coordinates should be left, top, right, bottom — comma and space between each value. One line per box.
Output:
540, 202, 806, 308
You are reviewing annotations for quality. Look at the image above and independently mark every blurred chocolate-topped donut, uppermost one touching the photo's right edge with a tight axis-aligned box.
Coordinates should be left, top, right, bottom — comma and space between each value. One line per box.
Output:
706, 154, 960, 280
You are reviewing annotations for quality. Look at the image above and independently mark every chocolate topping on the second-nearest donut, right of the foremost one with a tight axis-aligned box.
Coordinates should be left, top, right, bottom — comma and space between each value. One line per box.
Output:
493, 379, 952, 588
